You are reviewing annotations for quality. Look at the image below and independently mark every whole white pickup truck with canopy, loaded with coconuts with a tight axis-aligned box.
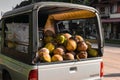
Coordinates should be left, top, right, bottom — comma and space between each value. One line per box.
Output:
0, 2, 104, 80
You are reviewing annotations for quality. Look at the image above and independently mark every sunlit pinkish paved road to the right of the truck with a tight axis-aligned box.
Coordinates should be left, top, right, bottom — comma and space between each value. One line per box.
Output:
103, 44, 120, 80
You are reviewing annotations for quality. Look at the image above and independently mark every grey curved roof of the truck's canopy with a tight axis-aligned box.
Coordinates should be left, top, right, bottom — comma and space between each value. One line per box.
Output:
2, 2, 98, 18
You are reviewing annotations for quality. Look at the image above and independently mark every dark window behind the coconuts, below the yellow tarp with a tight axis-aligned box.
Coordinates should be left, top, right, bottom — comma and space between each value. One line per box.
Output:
55, 17, 99, 49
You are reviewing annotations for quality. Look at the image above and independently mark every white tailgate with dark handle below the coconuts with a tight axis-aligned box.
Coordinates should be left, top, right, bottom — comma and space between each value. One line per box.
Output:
38, 59, 101, 80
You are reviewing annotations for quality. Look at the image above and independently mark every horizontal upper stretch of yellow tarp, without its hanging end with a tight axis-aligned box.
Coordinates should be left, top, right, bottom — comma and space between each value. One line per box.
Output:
50, 10, 95, 20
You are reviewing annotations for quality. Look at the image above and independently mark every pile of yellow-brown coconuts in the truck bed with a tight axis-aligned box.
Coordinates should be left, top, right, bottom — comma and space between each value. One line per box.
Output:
33, 30, 98, 63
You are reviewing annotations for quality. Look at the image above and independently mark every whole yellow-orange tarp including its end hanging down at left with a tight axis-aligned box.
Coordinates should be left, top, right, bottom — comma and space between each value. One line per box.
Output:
45, 10, 95, 32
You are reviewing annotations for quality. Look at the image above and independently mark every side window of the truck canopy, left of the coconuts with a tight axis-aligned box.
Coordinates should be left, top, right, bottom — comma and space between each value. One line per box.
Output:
4, 14, 29, 53
